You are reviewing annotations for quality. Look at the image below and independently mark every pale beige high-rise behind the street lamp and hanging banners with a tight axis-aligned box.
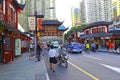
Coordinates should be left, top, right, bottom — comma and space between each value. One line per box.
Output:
19, 0, 56, 31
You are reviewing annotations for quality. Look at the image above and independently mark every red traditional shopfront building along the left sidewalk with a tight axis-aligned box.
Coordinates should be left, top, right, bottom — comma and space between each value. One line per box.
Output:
0, 0, 28, 63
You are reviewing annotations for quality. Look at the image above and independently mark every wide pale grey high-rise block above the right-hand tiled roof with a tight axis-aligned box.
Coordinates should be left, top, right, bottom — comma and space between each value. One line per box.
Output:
80, 0, 112, 23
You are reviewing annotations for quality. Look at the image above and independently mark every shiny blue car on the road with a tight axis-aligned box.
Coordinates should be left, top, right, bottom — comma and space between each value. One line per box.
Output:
67, 42, 83, 53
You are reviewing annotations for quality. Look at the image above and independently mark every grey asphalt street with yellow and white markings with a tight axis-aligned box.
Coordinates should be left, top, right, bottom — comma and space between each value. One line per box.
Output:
46, 52, 120, 80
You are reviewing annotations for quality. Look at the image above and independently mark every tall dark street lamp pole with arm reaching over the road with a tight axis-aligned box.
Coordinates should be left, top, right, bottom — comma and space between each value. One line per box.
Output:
34, 1, 55, 54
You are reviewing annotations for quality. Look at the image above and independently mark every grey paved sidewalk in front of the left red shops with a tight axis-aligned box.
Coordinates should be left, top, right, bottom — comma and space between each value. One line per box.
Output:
0, 53, 49, 80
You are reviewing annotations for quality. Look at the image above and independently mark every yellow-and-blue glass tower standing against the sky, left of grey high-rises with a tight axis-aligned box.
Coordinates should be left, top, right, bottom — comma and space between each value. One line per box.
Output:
71, 7, 80, 27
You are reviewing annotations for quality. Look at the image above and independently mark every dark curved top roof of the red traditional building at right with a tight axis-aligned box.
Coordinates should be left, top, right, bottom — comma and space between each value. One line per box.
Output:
83, 21, 112, 30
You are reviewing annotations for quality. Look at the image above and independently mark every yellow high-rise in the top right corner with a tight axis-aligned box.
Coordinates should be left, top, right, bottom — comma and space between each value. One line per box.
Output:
112, 0, 120, 18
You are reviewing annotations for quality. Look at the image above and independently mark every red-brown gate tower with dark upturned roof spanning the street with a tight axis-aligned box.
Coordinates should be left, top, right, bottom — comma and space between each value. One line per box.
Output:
39, 20, 67, 36
